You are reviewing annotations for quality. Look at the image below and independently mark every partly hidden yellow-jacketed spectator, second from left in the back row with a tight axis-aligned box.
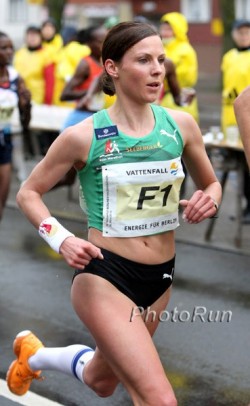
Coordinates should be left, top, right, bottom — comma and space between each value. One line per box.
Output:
41, 18, 63, 58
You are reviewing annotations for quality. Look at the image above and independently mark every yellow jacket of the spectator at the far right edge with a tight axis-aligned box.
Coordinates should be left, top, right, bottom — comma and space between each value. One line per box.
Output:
221, 48, 250, 131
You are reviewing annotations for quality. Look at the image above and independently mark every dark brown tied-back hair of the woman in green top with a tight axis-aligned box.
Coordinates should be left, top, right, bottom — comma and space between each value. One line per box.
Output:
102, 21, 159, 96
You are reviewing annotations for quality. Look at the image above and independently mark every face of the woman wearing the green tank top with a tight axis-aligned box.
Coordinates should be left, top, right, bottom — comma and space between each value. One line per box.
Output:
115, 35, 165, 103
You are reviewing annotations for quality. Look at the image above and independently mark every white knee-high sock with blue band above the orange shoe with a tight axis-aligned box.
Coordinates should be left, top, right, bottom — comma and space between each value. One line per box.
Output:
28, 344, 95, 382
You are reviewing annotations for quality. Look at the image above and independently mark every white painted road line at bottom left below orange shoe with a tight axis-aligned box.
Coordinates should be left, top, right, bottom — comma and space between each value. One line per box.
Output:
0, 379, 63, 406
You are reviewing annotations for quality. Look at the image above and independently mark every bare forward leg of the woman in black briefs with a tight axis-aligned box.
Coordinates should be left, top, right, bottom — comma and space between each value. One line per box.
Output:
72, 274, 177, 406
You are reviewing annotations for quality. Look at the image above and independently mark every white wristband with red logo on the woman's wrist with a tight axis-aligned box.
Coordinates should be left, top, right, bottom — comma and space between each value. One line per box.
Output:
38, 217, 74, 254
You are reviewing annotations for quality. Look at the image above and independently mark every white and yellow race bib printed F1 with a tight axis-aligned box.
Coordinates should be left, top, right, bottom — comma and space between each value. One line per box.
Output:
102, 158, 184, 237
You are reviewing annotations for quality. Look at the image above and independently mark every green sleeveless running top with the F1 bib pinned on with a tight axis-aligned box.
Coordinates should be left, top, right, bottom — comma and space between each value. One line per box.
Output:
78, 104, 184, 237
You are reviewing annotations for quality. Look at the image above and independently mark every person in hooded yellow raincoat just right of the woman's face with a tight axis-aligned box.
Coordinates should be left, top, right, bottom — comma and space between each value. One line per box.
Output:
159, 12, 199, 122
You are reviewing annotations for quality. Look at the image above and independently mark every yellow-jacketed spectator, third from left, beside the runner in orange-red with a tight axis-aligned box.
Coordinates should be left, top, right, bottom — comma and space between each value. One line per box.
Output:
53, 26, 90, 107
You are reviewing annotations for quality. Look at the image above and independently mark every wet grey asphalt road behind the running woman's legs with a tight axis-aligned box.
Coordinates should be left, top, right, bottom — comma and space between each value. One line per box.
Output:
0, 208, 250, 406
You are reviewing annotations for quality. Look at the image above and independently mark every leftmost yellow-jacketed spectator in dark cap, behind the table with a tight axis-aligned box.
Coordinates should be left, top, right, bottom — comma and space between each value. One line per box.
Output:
13, 26, 54, 104
